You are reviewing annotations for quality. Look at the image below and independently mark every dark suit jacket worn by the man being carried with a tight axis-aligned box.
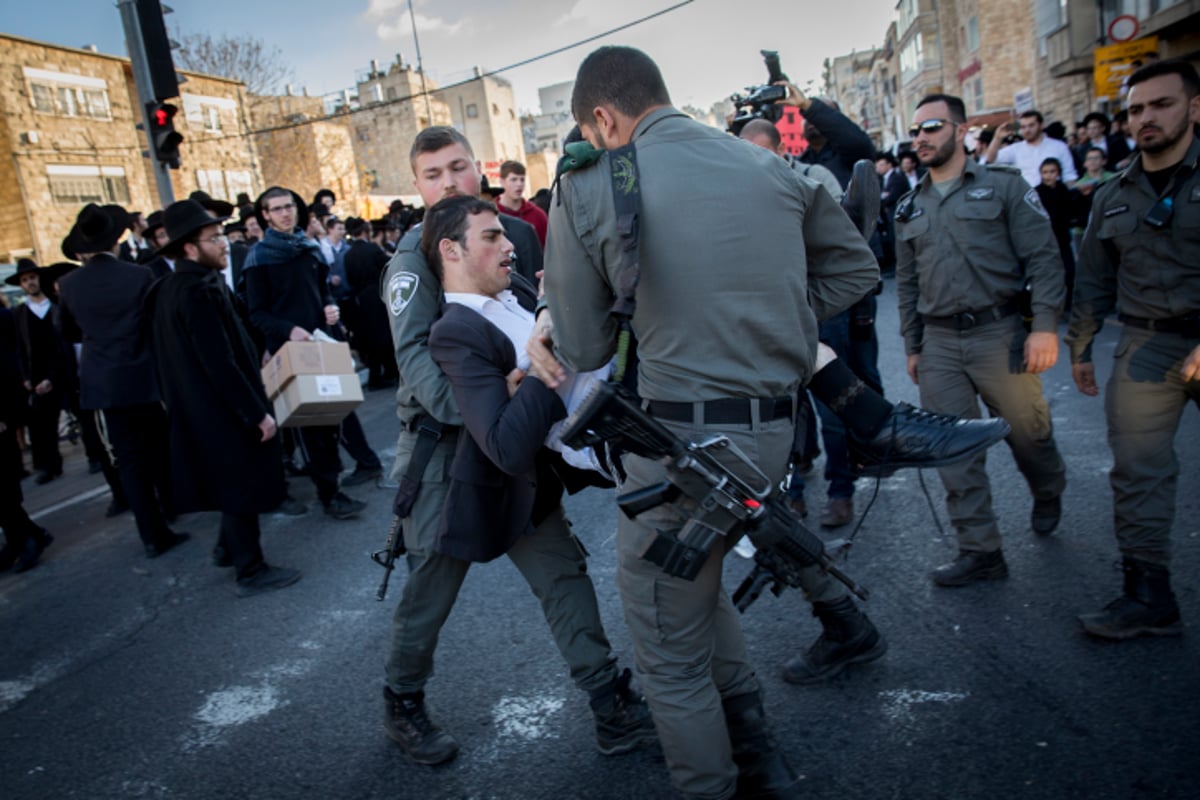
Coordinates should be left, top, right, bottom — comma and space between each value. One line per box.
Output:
430, 275, 566, 561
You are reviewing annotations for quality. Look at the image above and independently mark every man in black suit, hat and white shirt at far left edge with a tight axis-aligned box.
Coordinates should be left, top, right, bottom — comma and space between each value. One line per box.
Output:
5, 258, 70, 483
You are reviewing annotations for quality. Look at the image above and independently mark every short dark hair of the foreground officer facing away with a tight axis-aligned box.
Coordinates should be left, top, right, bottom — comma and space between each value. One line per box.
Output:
571, 44, 671, 125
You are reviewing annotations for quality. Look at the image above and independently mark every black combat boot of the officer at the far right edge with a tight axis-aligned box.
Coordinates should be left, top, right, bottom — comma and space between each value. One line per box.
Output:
1079, 555, 1183, 639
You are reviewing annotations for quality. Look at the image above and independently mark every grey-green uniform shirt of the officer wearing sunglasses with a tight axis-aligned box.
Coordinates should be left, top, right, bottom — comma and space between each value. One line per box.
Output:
895, 160, 1066, 355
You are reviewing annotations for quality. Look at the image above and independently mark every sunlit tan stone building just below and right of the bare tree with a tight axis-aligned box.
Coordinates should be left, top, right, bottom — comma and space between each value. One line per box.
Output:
247, 94, 364, 216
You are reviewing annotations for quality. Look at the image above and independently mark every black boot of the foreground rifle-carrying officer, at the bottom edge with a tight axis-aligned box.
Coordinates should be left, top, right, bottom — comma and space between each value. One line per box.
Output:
721, 692, 800, 800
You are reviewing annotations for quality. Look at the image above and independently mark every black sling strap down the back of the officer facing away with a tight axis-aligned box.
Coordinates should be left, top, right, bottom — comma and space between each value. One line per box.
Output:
608, 148, 642, 390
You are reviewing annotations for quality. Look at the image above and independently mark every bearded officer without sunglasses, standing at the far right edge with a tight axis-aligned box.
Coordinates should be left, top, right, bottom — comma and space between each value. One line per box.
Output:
1067, 60, 1200, 639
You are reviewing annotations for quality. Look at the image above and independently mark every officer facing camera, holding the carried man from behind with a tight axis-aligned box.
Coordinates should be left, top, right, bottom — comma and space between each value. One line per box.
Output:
382, 126, 654, 764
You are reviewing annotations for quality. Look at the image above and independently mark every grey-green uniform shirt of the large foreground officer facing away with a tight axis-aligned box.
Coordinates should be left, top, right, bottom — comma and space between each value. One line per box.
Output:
545, 107, 878, 401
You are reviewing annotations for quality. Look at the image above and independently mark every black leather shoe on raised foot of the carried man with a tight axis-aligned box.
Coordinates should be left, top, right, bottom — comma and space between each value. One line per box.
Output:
846, 403, 1012, 477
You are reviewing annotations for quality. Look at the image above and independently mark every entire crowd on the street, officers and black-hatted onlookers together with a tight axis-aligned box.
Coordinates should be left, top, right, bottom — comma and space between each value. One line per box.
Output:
0, 47, 1200, 800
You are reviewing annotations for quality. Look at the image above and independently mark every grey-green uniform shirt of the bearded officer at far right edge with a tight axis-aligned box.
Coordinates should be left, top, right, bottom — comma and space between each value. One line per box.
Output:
1067, 137, 1200, 363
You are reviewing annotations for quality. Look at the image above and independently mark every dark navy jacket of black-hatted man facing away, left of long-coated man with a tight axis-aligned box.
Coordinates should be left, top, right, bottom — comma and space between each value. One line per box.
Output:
58, 253, 158, 409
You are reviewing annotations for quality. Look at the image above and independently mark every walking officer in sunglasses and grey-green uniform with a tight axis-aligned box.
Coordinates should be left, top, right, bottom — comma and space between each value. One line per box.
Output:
895, 95, 1067, 587
